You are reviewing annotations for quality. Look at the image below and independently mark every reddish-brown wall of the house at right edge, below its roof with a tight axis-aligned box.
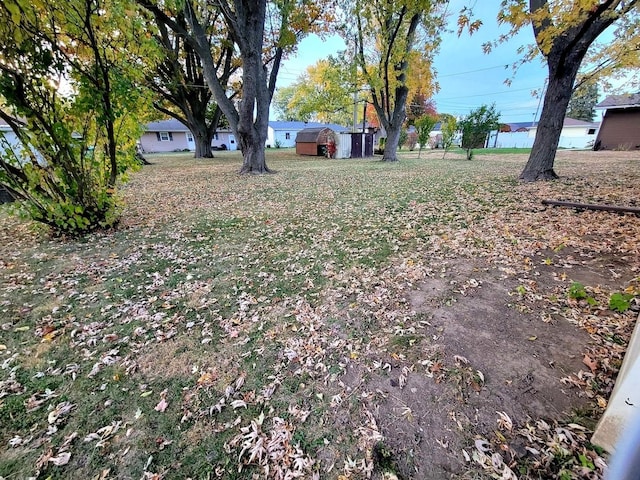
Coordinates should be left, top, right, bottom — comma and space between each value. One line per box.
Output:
597, 108, 640, 150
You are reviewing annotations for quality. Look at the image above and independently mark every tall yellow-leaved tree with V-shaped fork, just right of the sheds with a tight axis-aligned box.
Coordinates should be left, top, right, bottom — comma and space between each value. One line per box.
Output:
351, 0, 441, 162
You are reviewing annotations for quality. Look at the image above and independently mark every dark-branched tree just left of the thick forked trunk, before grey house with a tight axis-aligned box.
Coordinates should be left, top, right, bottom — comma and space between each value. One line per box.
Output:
141, 8, 239, 158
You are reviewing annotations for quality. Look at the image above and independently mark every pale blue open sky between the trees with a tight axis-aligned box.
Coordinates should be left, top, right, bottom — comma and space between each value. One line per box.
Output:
278, 0, 560, 123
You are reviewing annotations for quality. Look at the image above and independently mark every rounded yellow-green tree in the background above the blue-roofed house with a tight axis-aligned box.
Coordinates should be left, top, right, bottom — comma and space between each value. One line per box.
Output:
274, 56, 357, 125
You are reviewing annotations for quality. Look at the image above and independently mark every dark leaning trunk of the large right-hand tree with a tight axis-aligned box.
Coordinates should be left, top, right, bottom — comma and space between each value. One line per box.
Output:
520, 59, 580, 182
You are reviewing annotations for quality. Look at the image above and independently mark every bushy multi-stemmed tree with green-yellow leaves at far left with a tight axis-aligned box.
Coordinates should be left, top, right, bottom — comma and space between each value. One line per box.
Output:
0, 0, 146, 234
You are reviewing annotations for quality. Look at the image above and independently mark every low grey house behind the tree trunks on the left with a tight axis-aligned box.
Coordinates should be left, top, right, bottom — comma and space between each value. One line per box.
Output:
140, 118, 238, 153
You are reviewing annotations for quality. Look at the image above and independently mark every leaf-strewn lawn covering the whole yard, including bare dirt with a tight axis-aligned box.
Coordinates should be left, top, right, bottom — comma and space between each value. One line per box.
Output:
0, 151, 640, 479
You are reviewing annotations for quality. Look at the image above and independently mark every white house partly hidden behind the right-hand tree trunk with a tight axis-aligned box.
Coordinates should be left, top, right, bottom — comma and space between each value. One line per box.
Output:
486, 117, 599, 148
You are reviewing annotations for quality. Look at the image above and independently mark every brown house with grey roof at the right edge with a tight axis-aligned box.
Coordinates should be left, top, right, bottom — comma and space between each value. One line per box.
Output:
594, 93, 640, 150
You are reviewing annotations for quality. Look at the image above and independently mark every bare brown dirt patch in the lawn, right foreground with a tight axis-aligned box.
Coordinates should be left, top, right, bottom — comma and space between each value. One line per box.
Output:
366, 261, 589, 479
